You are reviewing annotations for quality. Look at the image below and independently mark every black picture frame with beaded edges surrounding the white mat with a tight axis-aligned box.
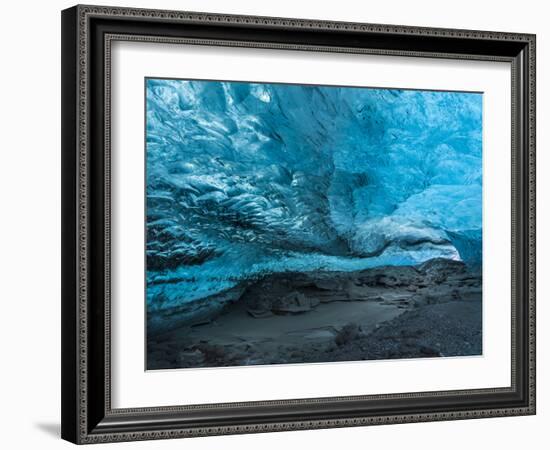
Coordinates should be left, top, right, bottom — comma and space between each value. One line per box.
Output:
62, 6, 535, 443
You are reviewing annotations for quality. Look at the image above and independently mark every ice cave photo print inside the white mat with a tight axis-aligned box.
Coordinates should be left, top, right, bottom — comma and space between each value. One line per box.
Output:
145, 78, 483, 370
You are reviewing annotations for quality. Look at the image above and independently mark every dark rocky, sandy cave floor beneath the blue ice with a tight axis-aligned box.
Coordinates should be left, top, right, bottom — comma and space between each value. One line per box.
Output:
147, 256, 482, 370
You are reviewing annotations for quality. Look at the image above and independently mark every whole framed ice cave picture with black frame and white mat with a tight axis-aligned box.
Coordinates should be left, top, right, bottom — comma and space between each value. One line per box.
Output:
62, 6, 535, 444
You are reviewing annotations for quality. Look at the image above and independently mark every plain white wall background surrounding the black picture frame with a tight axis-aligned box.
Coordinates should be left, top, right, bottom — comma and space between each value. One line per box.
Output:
0, 0, 550, 450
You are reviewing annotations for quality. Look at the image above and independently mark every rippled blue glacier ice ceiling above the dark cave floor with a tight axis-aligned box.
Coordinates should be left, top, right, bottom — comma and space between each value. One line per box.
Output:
146, 79, 482, 311
